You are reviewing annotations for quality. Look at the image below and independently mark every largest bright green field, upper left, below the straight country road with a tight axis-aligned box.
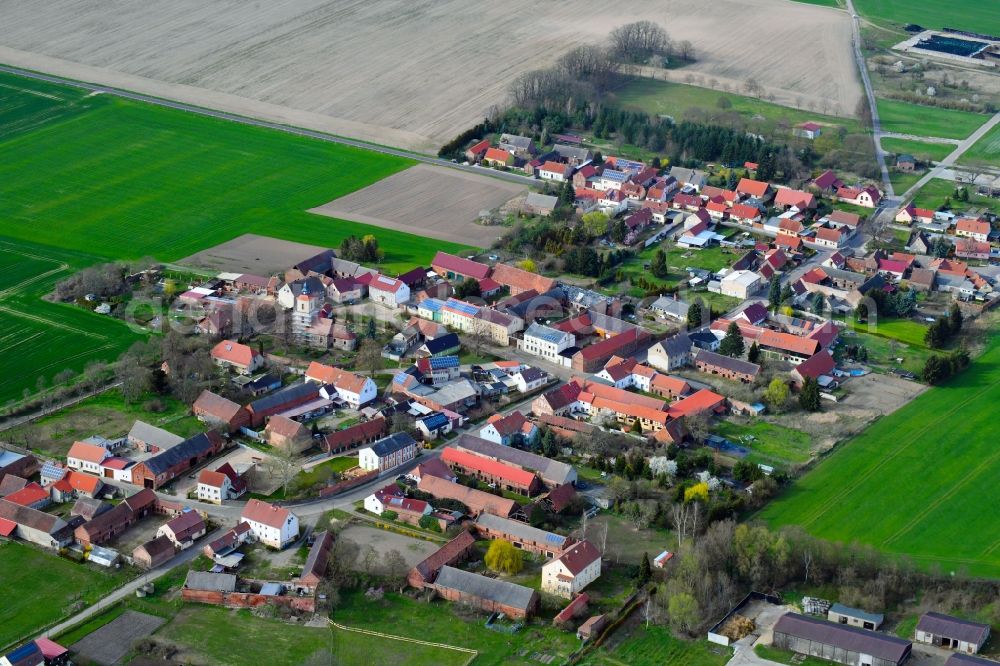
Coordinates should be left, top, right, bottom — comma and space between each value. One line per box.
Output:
0, 74, 474, 271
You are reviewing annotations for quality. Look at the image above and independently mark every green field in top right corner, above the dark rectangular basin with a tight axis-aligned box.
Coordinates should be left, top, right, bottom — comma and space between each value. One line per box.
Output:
854, 0, 1000, 35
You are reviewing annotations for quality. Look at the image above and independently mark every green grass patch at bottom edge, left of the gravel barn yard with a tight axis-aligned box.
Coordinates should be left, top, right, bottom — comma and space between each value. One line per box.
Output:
581, 624, 733, 666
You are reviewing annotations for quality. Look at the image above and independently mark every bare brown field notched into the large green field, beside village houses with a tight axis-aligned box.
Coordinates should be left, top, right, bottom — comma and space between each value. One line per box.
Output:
309, 164, 525, 247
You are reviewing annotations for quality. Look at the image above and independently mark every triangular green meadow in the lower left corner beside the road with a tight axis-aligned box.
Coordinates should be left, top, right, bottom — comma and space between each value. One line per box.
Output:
0, 541, 126, 649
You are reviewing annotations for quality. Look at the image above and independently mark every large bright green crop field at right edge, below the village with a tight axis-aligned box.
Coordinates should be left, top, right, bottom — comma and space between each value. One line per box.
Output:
759, 337, 1000, 577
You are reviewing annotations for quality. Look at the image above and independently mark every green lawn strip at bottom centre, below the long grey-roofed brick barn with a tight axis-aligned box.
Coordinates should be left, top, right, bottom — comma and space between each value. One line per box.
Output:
332, 592, 579, 666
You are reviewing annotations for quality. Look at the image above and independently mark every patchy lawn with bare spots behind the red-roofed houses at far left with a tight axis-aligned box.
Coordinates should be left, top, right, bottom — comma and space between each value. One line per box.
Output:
5, 389, 205, 458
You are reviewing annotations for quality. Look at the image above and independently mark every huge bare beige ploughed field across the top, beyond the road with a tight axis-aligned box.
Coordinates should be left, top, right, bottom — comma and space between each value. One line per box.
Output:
0, 0, 860, 151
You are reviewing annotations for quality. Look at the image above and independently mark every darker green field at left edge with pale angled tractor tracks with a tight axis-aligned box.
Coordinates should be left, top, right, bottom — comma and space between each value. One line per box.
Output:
0, 239, 142, 405
